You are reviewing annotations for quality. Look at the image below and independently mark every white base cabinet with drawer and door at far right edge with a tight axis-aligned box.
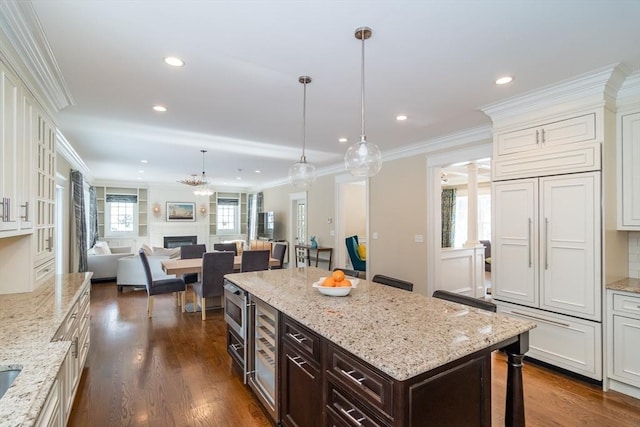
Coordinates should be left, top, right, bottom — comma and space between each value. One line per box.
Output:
607, 290, 640, 398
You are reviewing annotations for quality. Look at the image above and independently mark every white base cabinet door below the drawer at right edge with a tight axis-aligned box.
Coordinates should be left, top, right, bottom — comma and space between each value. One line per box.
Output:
612, 316, 640, 387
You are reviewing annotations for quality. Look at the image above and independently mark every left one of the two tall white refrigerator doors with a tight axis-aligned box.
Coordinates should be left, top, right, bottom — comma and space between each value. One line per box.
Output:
491, 179, 538, 306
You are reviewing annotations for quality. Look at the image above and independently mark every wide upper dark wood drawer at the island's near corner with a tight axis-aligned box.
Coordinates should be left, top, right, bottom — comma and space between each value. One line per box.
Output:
327, 344, 394, 417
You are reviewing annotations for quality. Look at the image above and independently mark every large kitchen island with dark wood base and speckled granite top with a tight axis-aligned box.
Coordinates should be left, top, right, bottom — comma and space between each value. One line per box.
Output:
226, 267, 535, 426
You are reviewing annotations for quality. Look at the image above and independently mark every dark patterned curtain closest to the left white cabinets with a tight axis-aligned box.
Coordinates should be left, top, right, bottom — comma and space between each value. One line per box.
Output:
70, 170, 88, 273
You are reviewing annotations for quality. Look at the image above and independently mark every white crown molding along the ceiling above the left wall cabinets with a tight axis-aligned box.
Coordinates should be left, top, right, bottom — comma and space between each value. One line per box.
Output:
0, 0, 74, 112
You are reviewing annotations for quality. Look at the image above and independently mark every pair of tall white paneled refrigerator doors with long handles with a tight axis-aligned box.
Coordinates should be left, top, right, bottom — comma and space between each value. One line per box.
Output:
492, 172, 601, 321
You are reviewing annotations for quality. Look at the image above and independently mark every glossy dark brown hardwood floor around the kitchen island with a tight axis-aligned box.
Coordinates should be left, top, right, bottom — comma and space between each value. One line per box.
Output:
69, 283, 640, 427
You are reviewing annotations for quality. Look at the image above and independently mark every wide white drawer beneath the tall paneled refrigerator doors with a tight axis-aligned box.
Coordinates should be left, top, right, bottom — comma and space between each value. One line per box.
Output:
498, 303, 602, 381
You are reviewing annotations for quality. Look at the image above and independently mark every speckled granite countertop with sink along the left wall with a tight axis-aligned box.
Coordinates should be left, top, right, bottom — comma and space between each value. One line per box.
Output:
0, 273, 91, 427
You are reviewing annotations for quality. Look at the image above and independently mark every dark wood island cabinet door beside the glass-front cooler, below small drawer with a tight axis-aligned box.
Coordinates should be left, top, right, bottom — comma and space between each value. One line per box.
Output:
280, 342, 323, 427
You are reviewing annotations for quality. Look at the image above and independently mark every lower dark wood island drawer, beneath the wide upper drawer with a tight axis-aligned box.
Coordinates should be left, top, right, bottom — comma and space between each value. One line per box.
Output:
326, 381, 391, 427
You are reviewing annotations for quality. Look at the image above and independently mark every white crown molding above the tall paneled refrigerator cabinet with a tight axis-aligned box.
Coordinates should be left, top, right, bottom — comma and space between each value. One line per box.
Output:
480, 64, 629, 127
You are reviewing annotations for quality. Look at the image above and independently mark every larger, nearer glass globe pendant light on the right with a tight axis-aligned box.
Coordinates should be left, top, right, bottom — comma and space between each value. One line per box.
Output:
344, 27, 382, 177
